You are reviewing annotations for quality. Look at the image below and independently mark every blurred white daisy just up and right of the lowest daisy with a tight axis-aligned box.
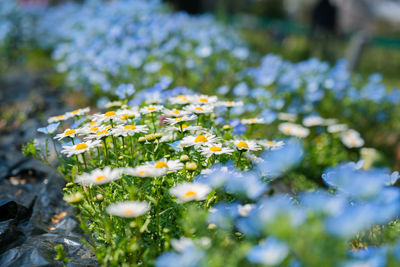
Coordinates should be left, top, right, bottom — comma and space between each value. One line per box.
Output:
169, 183, 212, 202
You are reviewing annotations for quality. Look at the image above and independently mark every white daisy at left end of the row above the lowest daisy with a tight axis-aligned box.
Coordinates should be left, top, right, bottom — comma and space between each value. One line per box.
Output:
75, 166, 121, 185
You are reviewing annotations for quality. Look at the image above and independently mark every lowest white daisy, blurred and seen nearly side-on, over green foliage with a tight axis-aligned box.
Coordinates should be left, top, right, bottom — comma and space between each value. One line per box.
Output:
106, 201, 150, 218
